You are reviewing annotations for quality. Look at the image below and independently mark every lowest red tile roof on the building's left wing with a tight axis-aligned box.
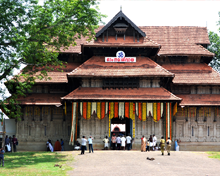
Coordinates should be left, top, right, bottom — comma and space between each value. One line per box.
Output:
13, 94, 64, 106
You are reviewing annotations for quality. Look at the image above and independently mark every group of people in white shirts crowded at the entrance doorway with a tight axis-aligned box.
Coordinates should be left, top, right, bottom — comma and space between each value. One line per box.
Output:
111, 133, 132, 150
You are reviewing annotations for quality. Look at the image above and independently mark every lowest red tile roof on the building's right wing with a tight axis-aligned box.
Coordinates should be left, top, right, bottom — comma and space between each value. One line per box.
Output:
176, 94, 220, 106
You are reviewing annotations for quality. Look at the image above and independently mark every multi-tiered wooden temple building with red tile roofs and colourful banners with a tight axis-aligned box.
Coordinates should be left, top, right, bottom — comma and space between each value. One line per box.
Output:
8, 11, 220, 150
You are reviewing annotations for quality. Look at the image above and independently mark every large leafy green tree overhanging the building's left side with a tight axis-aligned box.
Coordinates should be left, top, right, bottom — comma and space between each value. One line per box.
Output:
0, 0, 103, 119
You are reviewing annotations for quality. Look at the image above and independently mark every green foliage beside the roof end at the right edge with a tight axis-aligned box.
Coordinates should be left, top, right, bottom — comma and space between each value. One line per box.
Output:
208, 31, 220, 71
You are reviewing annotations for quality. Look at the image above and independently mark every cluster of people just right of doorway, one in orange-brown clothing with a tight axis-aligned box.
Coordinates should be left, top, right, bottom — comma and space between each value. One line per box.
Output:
141, 134, 159, 152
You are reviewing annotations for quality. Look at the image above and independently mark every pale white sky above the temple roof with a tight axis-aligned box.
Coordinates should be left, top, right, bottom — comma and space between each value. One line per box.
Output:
99, 0, 220, 33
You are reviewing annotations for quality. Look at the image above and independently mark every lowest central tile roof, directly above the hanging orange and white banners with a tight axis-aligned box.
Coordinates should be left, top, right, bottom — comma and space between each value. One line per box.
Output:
61, 87, 181, 101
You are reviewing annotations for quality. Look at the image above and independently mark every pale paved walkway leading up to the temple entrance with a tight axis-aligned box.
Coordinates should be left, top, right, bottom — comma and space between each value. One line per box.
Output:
69, 150, 220, 176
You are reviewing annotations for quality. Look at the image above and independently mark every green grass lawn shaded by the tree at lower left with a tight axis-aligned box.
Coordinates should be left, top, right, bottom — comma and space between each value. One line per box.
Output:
0, 152, 73, 176
